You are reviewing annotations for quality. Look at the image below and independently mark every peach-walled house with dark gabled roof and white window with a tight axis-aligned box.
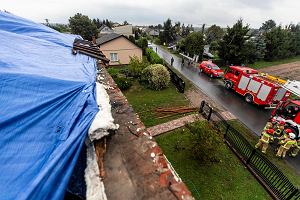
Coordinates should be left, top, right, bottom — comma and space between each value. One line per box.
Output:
96, 33, 143, 65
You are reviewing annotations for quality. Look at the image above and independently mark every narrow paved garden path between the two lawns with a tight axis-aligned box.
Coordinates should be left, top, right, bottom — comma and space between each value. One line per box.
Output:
147, 114, 203, 136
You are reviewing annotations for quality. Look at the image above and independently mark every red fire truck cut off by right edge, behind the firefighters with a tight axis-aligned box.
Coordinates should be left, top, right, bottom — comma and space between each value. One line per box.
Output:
271, 81, 300, 138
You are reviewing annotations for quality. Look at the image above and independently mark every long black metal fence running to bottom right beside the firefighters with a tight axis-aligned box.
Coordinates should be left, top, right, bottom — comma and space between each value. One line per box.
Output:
199, 101, 300, 200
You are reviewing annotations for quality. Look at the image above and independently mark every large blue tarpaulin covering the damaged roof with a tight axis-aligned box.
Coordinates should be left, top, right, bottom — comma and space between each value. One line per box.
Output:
0, 12, 98, 200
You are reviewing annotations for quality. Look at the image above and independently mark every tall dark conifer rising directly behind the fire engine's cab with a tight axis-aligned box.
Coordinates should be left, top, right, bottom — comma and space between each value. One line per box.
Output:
218, 19, 251, 65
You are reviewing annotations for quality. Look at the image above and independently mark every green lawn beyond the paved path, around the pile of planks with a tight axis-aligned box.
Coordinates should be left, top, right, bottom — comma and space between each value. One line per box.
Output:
123, 81, 189, 127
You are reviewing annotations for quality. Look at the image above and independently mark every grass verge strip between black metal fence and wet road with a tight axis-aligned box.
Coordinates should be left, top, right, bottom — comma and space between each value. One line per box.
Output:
225, 120, 300, 187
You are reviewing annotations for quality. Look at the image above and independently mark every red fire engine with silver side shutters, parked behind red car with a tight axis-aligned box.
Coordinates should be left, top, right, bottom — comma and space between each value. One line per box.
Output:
224, 66, 291, 107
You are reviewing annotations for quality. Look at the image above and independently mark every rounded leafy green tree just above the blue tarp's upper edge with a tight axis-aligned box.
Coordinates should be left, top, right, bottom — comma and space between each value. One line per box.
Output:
69, 13, 98, 40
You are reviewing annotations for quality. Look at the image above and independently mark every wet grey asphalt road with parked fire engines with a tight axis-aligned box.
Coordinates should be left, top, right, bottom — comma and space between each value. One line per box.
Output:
152, 44, 300, 173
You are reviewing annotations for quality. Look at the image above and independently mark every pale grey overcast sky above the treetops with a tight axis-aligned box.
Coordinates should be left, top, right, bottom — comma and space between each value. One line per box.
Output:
0, 0, 300, 28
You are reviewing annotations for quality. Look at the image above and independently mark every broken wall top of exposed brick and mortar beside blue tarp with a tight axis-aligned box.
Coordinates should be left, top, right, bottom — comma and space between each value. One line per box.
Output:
96, 69, 192, 200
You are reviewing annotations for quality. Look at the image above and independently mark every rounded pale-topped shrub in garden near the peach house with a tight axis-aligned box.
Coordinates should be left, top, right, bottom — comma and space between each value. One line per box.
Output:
142, 64, 170, 90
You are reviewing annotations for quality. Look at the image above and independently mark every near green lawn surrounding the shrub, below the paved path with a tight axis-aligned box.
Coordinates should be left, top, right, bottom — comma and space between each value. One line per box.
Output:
156, 121, 271, 200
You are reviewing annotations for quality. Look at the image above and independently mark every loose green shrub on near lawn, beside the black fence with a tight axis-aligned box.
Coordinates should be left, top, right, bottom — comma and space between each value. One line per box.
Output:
186, 122, 224, 163
